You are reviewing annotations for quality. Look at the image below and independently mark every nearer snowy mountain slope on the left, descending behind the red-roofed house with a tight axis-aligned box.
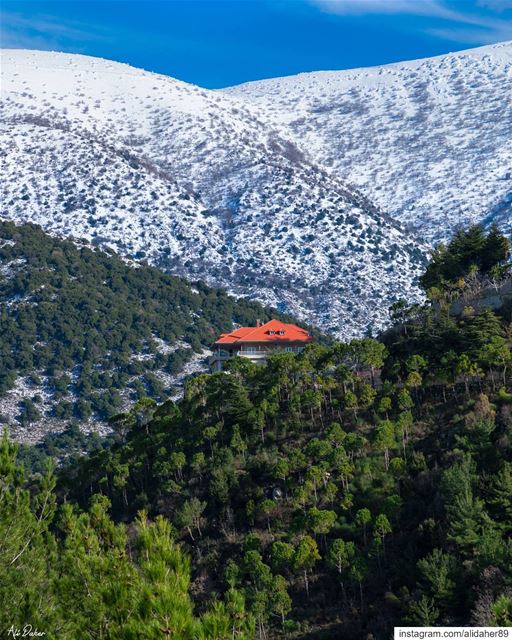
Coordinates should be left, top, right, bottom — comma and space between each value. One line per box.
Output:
0, 50, 424, 336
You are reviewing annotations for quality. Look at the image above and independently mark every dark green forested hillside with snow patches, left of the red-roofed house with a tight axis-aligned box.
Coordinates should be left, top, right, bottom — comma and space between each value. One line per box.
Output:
0, 221, 304, 441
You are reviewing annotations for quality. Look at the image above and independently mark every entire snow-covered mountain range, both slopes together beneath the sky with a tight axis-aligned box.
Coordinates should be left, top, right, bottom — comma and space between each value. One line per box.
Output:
0, 44, 512, 336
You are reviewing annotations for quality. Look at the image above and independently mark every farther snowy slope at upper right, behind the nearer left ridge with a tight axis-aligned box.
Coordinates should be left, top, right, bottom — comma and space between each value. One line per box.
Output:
227, 42, 512, 241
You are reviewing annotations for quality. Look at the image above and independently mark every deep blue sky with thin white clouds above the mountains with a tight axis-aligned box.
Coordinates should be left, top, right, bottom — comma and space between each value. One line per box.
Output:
0, 0, 512, 87
